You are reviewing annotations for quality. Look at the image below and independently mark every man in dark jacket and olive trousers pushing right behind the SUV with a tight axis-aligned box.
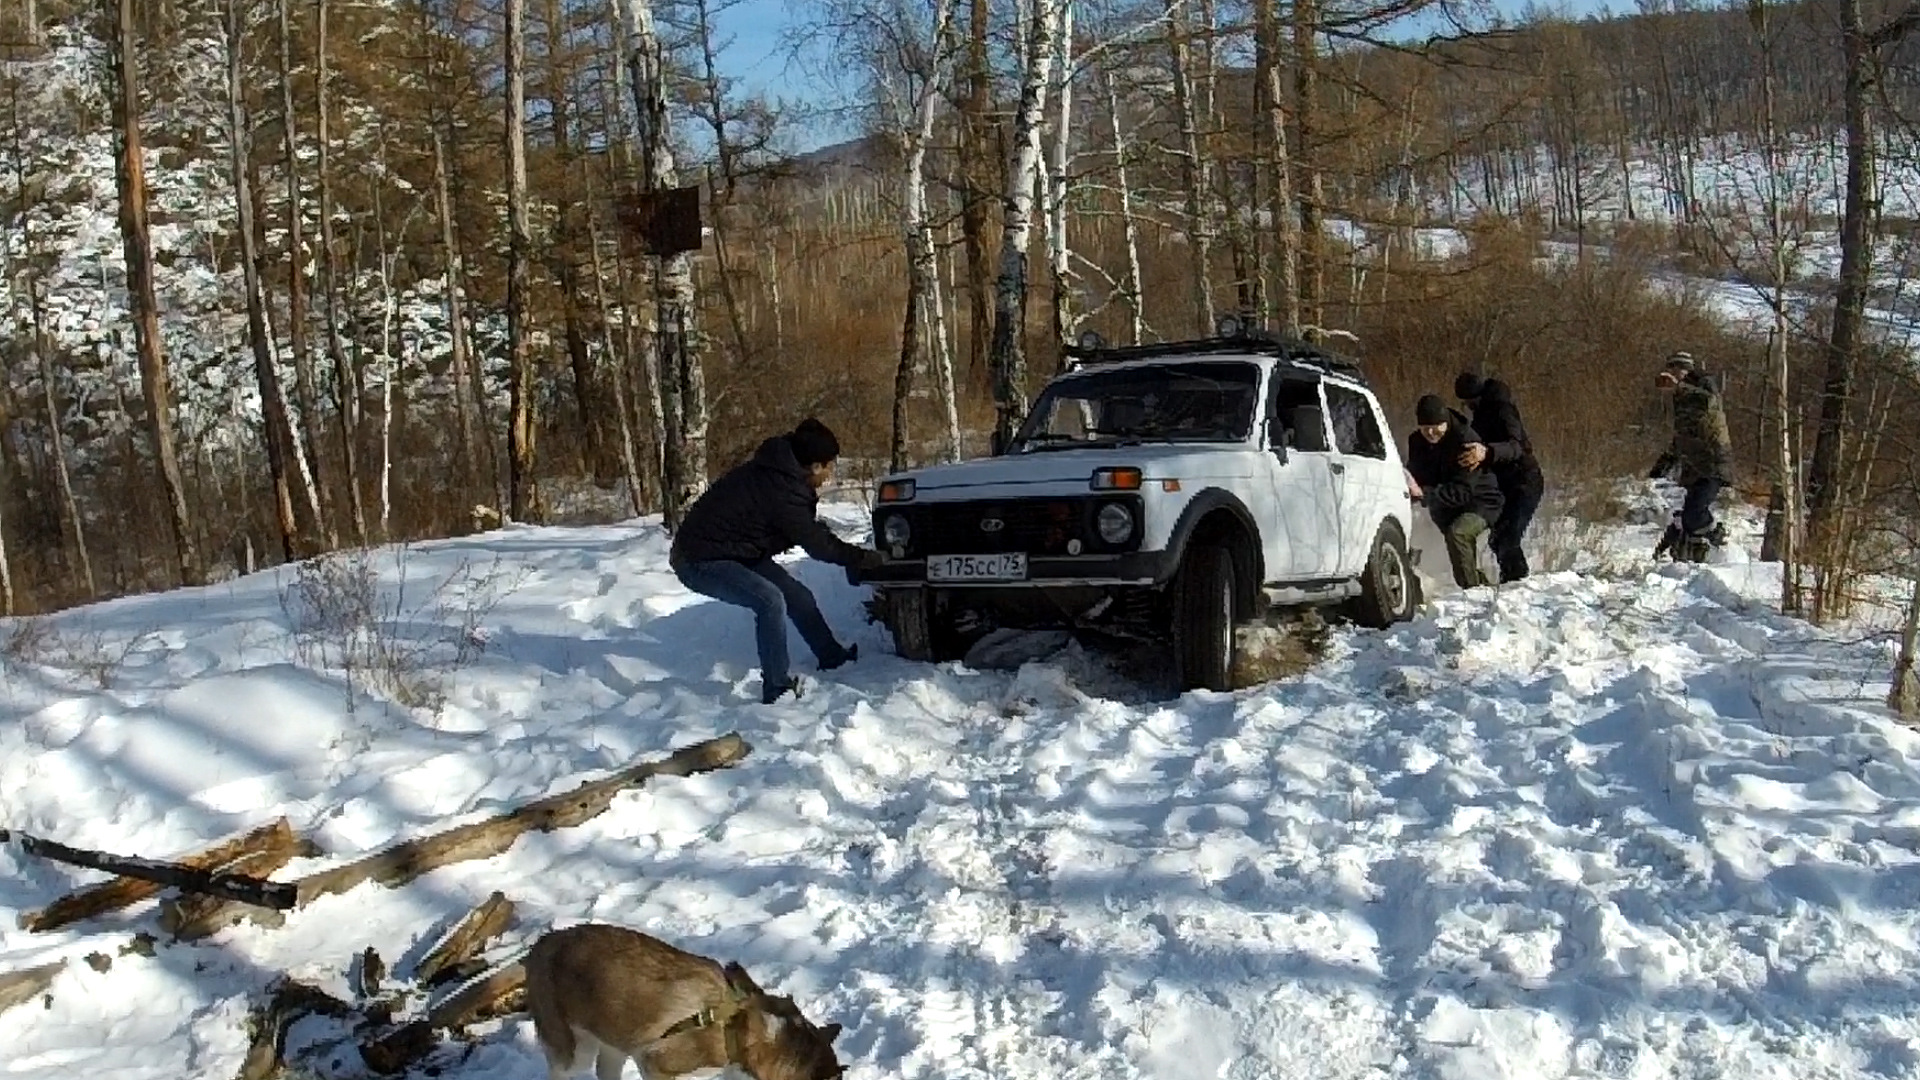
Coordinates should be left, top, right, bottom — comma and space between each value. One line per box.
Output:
1407, 394, 1505, 588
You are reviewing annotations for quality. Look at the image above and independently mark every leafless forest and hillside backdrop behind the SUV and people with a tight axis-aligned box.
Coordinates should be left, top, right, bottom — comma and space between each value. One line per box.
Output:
0, 0, 1920, 630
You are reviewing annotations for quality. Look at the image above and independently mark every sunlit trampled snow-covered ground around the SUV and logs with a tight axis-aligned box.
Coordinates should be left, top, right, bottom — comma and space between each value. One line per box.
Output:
0, 491, 1920, 1080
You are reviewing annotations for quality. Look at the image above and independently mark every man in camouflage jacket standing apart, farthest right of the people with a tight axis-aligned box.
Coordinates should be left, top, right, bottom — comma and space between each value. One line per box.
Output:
1649, 352, 1734, 561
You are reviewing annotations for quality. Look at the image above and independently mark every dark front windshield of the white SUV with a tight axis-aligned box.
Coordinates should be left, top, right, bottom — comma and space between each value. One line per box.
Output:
1012, 359, 1260, 454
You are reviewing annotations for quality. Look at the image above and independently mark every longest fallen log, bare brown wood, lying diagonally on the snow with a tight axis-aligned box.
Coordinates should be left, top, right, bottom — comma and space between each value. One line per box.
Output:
168, 734, 753, 942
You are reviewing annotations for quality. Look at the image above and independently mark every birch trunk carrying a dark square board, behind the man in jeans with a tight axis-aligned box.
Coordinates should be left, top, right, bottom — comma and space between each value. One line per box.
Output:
626, 0, 707, 528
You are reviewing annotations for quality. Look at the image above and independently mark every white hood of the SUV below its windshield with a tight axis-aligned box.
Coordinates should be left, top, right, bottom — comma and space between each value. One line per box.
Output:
900, 442, 1261, 498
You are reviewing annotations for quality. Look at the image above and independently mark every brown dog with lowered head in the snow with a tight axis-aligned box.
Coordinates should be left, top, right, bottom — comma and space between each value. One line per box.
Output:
522, 922, 845, 1080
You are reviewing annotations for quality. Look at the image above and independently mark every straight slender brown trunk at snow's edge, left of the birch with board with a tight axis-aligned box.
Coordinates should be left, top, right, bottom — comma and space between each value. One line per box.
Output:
507, 0, 540, 521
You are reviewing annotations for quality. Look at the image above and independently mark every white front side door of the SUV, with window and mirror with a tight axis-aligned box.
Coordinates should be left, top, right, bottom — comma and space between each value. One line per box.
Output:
1267, 367, 1340, 580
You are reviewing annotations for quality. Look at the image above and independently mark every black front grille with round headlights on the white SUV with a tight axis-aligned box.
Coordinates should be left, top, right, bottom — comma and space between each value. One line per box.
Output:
874, 496, 1139, 557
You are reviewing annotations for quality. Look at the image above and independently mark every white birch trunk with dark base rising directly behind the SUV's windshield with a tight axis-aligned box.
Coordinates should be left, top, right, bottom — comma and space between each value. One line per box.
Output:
991, 0, 1068, 454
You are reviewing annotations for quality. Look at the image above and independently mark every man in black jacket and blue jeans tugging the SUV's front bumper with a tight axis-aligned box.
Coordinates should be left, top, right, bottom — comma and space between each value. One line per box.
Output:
666, 417, 881, 703
